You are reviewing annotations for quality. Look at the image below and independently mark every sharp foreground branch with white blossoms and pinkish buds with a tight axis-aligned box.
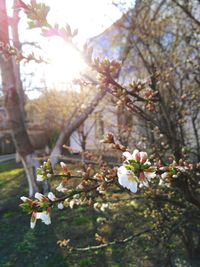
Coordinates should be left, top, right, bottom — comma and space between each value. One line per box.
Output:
21, 151, 190, 228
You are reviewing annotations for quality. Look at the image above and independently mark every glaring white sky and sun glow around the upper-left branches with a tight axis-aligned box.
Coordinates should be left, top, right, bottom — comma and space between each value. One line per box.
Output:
7, 0, 134, 97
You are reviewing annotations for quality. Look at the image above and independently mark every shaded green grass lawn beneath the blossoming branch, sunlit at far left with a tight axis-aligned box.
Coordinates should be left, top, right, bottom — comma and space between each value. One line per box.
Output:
0, 162, 199, 267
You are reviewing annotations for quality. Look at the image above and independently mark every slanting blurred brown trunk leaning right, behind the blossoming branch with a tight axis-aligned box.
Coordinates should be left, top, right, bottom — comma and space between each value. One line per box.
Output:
50, 90, 106, 169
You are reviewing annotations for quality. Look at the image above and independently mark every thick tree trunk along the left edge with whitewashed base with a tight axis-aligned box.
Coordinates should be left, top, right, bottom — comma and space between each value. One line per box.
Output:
0, 0, 39, 196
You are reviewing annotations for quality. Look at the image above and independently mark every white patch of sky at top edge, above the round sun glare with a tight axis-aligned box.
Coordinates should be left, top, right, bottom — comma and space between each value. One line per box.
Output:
44, 0, 121, 40
